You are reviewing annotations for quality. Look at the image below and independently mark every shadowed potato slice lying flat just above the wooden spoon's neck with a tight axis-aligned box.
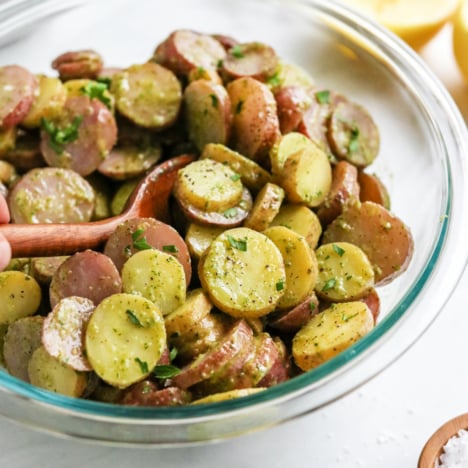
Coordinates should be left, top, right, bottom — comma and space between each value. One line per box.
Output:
97, 146, 162, 180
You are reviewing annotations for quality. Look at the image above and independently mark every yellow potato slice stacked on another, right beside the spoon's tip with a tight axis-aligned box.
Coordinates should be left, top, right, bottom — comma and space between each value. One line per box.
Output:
174, 159, 243, 212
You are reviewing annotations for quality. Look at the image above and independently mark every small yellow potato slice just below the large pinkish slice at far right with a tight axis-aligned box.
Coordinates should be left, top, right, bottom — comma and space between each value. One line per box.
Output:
315, 242, 374, 302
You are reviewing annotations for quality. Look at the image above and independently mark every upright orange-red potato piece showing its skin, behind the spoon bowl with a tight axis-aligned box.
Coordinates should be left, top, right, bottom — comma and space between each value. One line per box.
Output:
227, 77, 280, 161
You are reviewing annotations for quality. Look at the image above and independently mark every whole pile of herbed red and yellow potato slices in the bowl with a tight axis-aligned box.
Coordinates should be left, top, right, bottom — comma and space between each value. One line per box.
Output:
0, 29, 413, 406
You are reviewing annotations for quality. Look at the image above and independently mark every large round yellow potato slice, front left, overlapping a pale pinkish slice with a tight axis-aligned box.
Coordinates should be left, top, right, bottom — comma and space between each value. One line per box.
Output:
85, 292, 167, 388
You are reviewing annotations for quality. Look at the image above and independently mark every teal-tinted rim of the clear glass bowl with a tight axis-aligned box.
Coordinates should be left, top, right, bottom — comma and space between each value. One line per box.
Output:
0, 0, 468, 434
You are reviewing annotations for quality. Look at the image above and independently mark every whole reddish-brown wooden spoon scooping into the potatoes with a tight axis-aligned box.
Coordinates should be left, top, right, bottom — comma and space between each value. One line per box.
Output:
0, 155, 194, 257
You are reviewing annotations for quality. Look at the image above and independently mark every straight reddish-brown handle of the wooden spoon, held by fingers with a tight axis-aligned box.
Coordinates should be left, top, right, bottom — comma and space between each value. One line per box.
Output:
0, 216, 122, 257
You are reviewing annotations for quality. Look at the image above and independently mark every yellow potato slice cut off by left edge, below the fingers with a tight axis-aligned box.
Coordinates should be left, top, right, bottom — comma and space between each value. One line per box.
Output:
0, 271, 42, 324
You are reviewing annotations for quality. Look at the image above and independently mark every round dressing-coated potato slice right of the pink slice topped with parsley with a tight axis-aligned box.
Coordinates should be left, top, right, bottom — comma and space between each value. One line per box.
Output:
111, 62, 182, 130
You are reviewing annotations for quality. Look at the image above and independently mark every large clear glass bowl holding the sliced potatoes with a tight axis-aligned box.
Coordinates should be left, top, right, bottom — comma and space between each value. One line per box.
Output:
0, 0, 468, 446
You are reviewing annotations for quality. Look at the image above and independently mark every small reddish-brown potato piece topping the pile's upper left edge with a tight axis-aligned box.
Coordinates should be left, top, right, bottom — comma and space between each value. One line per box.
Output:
52, 49, 103, 81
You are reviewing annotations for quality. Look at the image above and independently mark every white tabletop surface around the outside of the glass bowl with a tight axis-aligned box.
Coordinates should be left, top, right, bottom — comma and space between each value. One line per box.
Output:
0, 23, 468, 468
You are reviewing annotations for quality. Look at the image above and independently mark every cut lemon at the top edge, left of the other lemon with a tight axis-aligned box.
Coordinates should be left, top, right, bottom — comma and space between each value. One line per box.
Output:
343, 0, 460, 49
